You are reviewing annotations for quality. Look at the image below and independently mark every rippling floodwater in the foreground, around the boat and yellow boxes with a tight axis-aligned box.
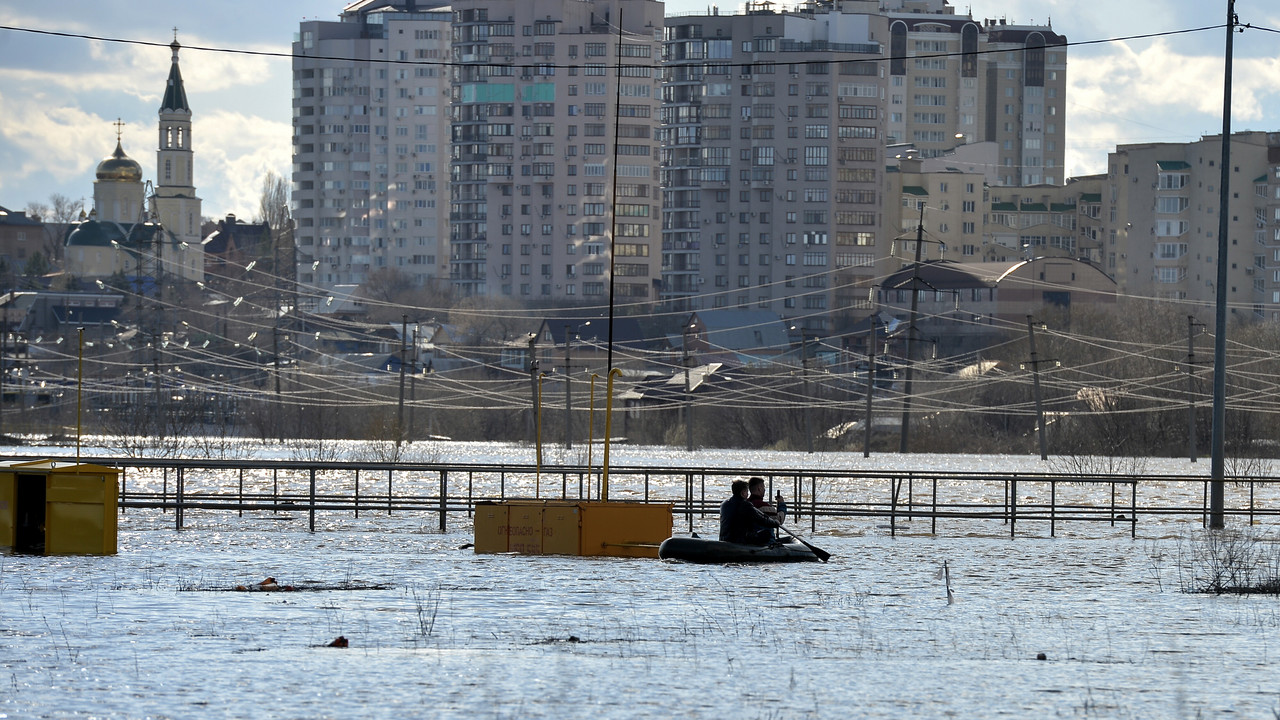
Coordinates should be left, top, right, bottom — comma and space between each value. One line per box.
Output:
0, 440, 1280, 720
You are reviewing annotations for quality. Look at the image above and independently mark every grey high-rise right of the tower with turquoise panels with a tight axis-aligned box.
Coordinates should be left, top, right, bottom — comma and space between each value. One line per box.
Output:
660, 1, 884, 331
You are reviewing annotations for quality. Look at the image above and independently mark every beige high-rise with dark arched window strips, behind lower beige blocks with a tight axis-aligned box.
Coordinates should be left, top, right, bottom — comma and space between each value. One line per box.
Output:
882, 0, 1066, 186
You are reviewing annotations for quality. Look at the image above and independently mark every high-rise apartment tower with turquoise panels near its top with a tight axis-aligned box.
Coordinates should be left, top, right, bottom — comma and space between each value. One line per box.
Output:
447, 0, 663, 305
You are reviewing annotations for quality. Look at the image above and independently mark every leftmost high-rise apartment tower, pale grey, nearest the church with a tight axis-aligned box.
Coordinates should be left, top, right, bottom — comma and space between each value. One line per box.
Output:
293, 0, 451, 288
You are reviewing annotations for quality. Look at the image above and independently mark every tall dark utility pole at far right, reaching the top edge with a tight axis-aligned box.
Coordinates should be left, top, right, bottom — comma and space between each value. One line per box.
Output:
1208, 0, 1238, 529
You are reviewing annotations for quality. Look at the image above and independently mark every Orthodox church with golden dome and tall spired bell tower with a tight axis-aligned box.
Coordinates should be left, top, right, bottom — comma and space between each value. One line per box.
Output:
65, 38, 205, 286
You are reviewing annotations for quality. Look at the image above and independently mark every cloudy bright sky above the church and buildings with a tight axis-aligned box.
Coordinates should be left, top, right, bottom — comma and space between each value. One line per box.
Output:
0, 0, 1280, 219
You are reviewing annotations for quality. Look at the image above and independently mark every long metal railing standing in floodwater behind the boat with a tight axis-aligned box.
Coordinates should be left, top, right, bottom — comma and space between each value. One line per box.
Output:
20, 457, 1259, 537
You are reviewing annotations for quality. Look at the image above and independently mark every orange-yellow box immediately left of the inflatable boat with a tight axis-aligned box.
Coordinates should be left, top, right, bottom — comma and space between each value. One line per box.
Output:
579, 502, 672, 557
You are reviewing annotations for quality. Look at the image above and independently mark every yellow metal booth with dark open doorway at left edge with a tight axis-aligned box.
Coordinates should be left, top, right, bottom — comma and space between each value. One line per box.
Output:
0, 460, 120, 555
